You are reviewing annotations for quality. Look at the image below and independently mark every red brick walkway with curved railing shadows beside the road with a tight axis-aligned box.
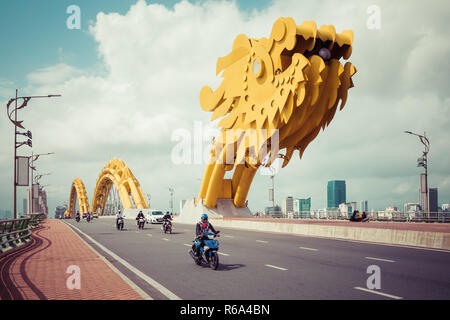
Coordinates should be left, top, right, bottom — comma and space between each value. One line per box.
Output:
0, 219, 142, 300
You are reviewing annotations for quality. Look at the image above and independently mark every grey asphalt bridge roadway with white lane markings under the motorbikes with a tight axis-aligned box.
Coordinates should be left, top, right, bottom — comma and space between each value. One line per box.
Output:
64, 217, 450, 300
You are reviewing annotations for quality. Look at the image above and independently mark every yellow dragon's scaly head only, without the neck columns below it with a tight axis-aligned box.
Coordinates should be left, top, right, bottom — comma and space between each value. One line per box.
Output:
200, 18, 356, 167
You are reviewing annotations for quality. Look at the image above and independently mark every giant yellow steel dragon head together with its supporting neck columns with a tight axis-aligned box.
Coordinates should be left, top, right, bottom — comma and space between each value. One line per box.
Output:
196, 18, 356, 208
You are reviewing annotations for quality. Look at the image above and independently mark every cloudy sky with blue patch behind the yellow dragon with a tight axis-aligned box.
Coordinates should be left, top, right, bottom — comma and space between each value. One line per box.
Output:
0, 0, 450, 218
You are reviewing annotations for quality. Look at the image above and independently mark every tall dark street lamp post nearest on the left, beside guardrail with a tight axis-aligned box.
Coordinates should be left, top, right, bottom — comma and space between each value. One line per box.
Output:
6, 89, 61, 219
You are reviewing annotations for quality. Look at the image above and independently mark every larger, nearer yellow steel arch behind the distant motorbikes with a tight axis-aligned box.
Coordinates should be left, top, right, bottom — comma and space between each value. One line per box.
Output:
91, 158, 148, 215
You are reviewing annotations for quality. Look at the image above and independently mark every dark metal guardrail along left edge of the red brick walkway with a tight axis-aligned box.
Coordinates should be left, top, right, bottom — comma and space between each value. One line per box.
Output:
0, 213, 46, 254
